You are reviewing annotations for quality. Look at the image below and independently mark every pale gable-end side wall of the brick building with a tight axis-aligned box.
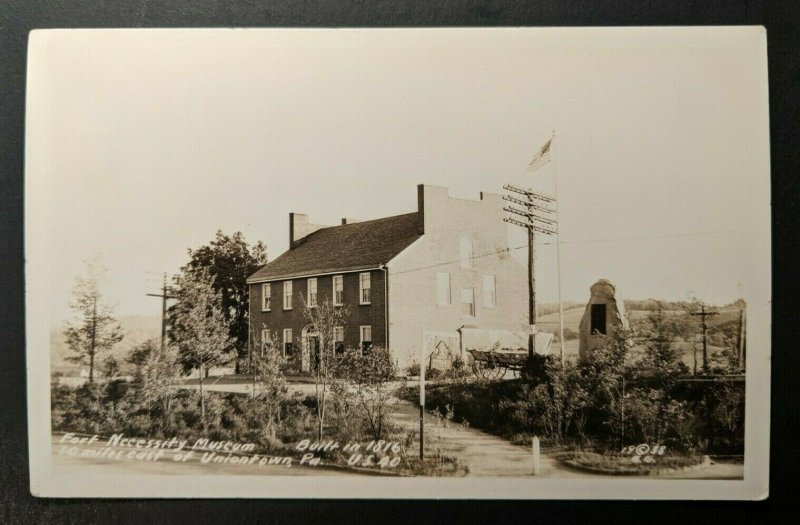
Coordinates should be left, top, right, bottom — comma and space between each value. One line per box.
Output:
387, 186, 528, 367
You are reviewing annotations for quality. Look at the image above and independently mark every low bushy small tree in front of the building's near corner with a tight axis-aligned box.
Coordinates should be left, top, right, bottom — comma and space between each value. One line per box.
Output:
341, 348, 397, 440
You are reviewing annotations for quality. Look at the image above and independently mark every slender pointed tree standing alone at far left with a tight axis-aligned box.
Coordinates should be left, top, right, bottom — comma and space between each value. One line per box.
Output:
64, 263, 124, 383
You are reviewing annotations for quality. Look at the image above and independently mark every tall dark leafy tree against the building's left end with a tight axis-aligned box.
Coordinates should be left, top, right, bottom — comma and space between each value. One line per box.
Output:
181, 231, 267, 373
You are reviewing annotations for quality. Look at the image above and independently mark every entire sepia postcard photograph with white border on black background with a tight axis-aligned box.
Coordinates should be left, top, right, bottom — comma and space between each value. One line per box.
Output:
25, 27, 771, 500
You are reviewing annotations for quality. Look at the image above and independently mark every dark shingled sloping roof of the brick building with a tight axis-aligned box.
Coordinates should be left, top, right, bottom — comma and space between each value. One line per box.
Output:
247, 212, 421, 282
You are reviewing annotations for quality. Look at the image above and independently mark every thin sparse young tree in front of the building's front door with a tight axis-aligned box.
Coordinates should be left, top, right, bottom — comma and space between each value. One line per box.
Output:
300, 295, 350, 439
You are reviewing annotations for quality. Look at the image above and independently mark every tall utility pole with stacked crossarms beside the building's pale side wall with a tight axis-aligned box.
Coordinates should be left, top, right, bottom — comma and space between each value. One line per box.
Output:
503, 184, 563, 361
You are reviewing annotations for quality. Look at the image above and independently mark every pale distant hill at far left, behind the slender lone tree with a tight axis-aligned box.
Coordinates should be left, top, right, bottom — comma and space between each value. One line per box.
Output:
50, 316, 161, 376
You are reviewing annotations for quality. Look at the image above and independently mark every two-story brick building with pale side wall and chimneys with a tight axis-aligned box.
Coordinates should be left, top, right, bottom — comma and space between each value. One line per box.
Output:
247, 185, 527, 370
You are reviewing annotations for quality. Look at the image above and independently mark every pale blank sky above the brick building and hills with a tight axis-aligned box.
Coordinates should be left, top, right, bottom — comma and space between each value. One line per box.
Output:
26, 28, 770, 325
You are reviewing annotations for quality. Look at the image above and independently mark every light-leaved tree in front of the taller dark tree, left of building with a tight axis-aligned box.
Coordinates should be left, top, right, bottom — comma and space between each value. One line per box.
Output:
170, 268, 234, 429
